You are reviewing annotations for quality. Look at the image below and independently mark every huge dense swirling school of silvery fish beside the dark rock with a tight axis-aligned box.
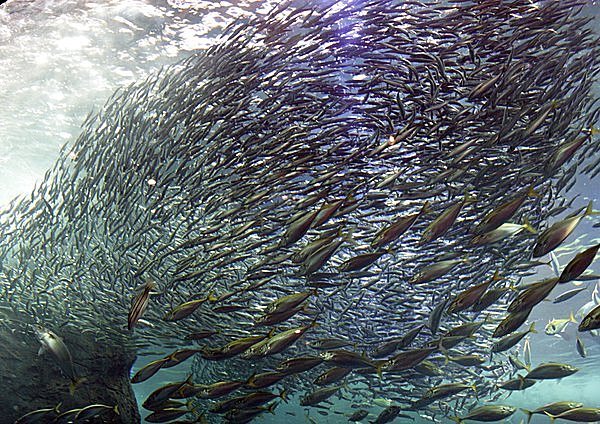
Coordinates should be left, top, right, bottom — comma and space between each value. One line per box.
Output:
0, 0, 600, 423
